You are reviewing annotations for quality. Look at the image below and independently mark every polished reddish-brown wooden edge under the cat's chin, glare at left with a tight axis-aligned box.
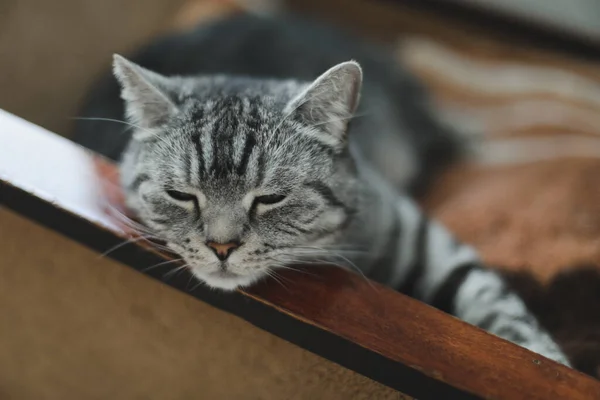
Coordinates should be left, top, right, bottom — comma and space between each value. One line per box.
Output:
0, 110, 600, 400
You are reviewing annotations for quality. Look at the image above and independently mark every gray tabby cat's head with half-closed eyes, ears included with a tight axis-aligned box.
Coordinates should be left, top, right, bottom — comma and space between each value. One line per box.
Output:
114, 56, 362, 290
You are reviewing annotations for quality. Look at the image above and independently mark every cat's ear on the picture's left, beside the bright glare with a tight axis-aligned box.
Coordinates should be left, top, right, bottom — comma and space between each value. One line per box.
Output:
113, 54, 177, 136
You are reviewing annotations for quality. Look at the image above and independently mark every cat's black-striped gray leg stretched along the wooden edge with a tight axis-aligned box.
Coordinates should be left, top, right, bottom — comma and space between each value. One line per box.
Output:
384, 199, 569, 365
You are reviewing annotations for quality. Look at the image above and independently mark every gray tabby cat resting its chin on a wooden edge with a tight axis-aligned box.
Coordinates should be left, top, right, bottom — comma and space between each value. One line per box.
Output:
75, 16, 567, 364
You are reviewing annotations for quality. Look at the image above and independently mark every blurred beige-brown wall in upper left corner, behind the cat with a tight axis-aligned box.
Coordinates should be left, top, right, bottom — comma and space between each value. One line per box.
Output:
0, 0, 189, 133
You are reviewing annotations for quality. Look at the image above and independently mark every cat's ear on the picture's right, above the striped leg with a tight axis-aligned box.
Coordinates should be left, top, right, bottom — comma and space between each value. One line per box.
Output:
286, 61, 362, 146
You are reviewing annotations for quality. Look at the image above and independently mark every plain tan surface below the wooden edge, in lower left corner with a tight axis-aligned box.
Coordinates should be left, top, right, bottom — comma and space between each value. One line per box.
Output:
0, 208, 402, 400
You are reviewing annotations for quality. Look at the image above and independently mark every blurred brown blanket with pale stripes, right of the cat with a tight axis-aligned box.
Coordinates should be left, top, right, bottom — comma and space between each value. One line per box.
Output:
400, 39, 600, 377
